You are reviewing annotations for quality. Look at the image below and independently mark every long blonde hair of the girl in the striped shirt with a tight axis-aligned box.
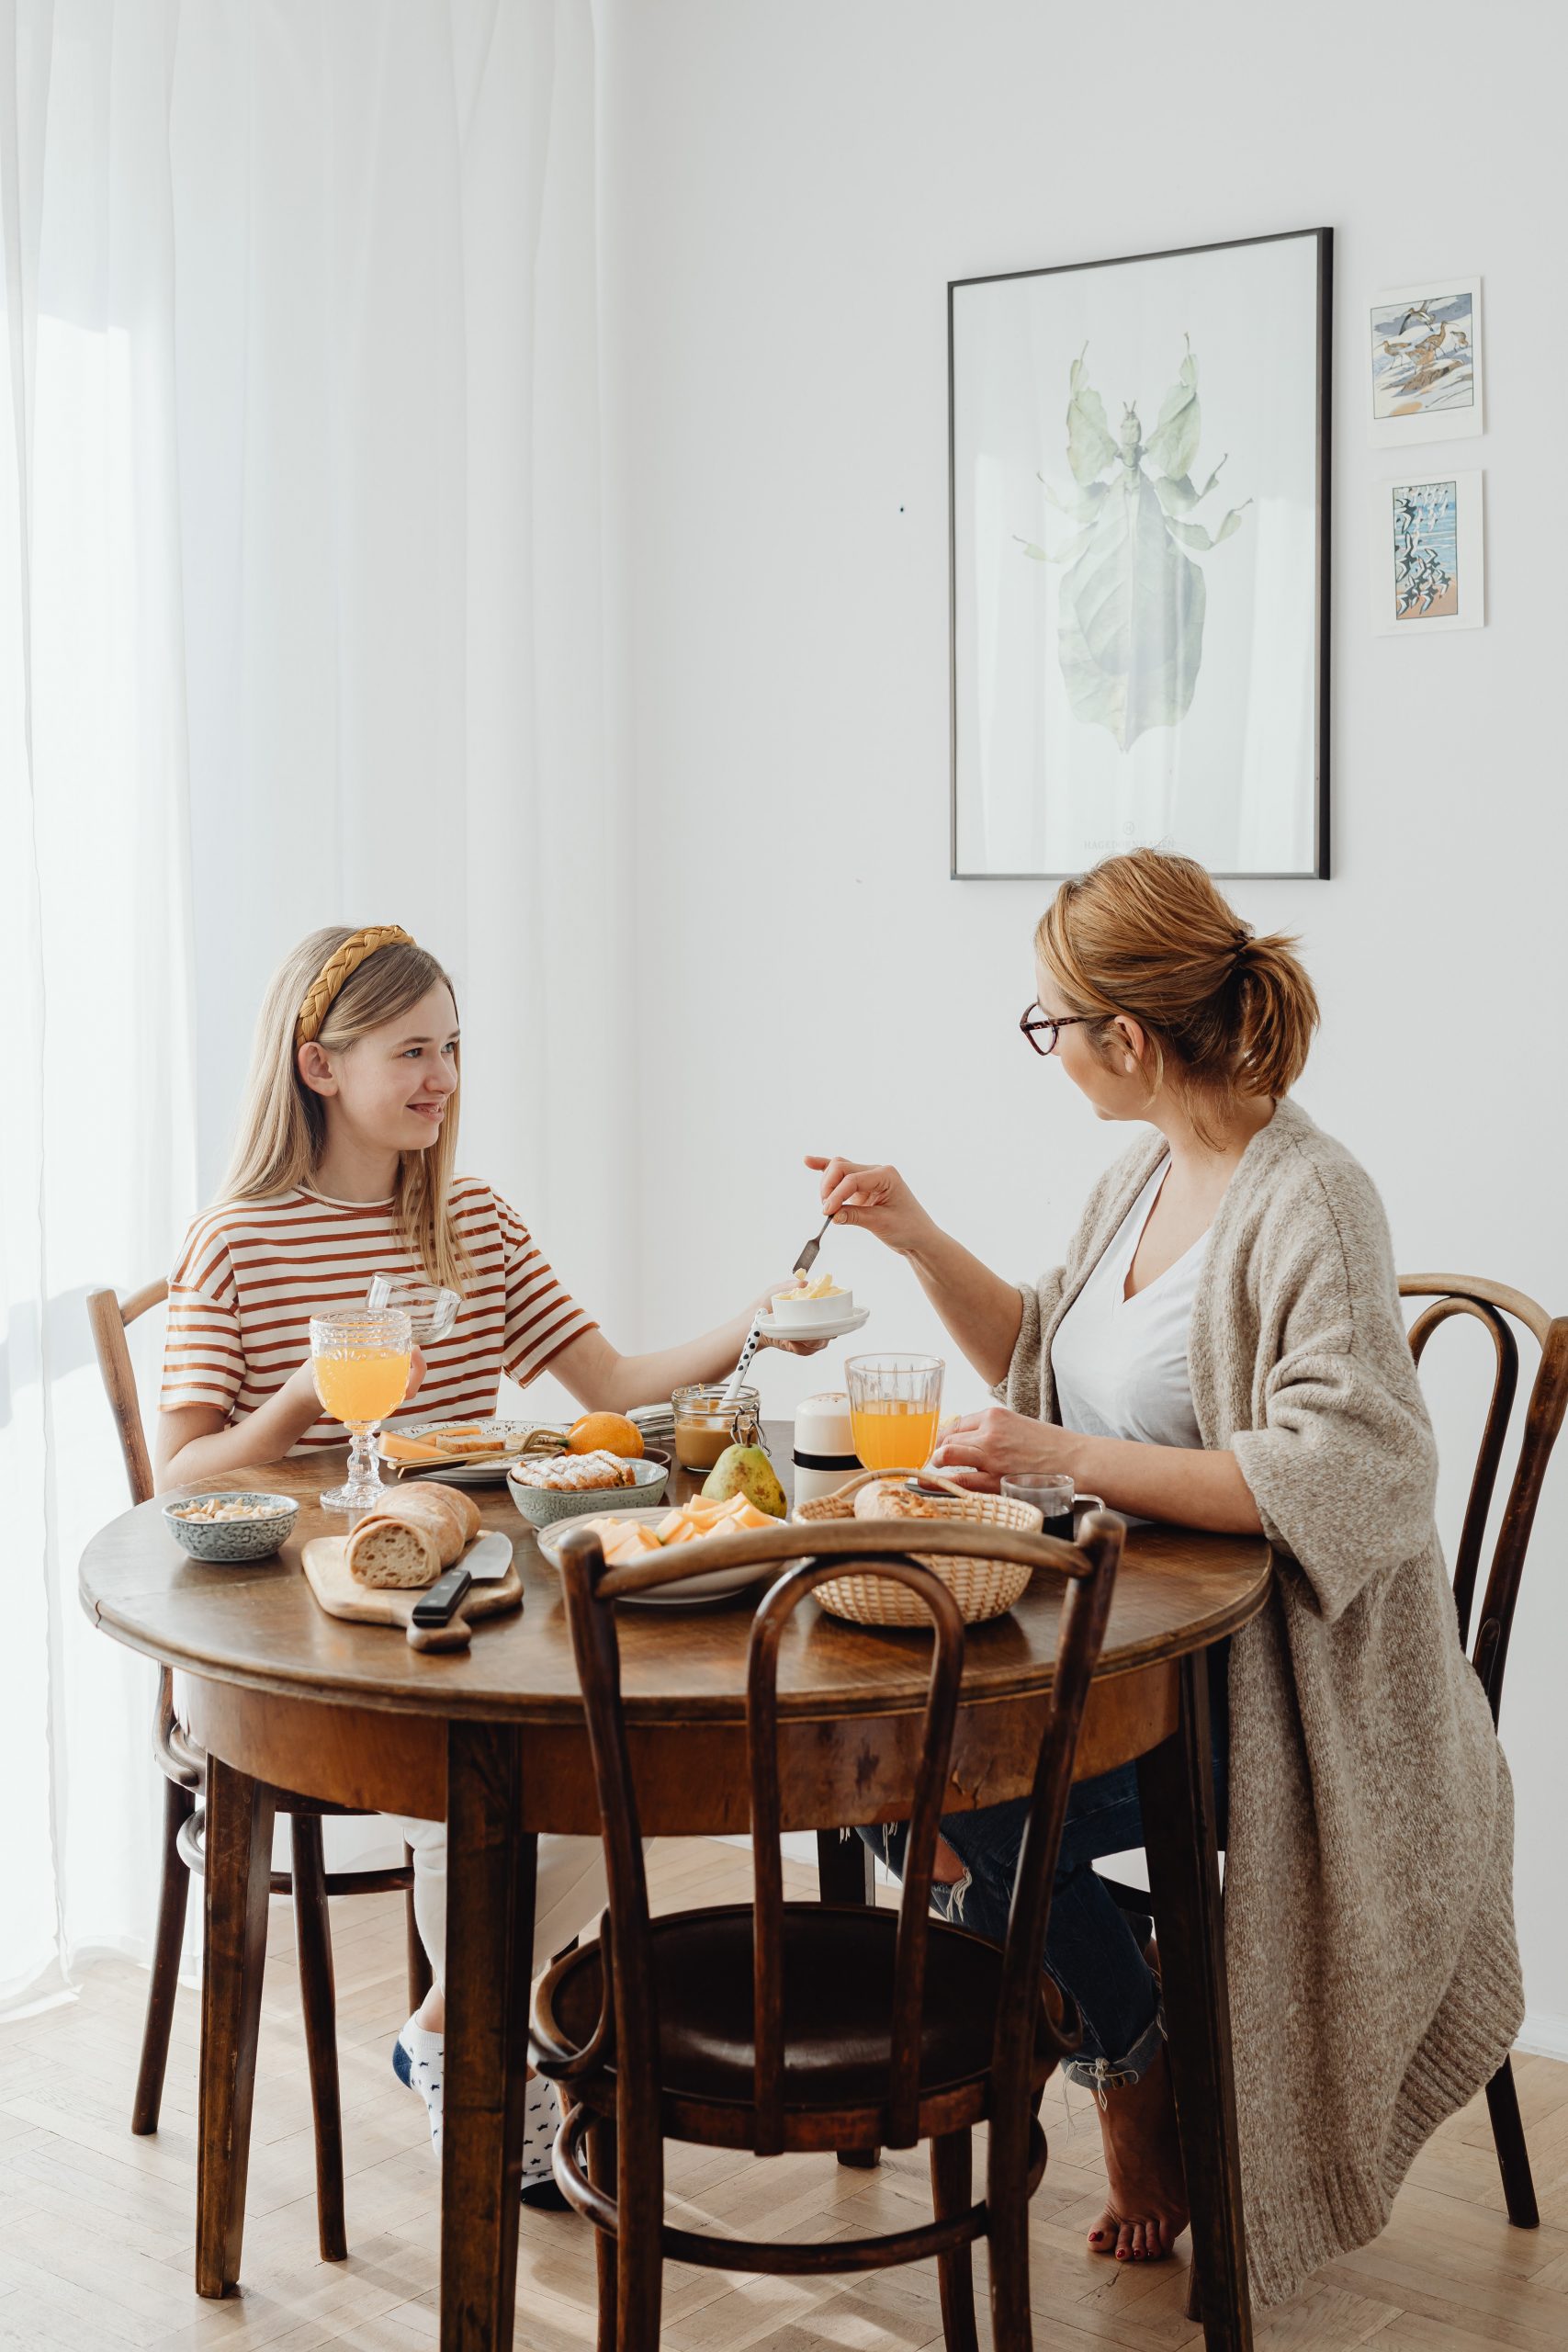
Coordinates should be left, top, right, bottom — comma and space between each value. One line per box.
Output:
221, 924, 472, 1291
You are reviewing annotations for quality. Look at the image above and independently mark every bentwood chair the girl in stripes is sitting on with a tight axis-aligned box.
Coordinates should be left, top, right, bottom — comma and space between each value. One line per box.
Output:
87, 1282, 430, 2263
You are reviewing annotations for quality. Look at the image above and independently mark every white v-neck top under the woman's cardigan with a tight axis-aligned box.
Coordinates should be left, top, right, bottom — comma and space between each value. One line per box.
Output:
1051, 1158, 1208, 1446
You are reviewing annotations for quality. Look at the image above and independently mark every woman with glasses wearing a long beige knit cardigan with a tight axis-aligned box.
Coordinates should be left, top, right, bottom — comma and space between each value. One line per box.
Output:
808, 849, 1523, 2302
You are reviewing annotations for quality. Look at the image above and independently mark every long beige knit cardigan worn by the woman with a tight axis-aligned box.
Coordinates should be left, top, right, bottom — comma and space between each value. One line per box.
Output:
997, 1101, 1523, 2302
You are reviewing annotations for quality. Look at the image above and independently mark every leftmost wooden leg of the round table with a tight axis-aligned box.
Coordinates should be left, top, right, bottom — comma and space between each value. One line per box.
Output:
195, 1757, 273, 2296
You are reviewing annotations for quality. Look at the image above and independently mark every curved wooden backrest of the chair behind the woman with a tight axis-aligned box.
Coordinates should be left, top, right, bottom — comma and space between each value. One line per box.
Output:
1399, 1275, 1568, 1722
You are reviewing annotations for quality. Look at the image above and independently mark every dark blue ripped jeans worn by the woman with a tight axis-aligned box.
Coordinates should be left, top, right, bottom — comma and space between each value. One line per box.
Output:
861, 1642, 1229, 2091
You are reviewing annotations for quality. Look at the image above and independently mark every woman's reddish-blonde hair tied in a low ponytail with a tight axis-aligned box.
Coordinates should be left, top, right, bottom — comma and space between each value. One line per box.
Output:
1034, 849, 1319, 1134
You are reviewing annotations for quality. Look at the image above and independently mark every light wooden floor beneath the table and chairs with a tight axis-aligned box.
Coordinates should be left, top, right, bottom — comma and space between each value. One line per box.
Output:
0, 1841, 1568, 2352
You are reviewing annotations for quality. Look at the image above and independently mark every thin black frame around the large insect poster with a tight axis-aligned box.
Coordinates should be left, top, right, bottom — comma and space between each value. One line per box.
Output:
947, 228, 1333, 882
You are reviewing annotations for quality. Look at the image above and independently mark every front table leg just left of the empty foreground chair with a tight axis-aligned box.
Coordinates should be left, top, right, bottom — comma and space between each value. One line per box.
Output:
442, 1722, 536, 2352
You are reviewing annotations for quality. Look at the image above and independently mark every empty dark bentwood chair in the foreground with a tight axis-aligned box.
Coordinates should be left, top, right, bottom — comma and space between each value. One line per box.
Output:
531, 1512, 1122, 2352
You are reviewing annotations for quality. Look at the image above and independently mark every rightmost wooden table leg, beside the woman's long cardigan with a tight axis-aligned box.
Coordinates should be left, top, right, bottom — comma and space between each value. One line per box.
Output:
1138, 1651, 1253, 2352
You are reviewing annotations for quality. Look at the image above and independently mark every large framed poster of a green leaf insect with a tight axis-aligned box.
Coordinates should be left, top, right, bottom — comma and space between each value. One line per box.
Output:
947, 228, 1333, 879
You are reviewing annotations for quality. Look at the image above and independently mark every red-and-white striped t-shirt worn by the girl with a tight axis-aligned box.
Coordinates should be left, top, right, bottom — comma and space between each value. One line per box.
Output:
160, 1176, 594, 1453
